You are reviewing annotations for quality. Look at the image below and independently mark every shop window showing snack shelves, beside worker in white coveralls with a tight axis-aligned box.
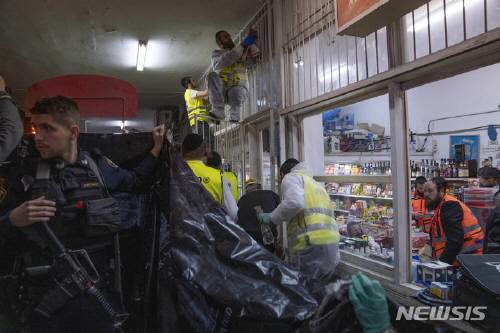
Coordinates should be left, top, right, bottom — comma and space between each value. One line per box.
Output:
304, 95, 394, 274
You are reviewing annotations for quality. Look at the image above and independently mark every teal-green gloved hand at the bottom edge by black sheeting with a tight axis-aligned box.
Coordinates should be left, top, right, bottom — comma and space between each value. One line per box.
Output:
349, 273, 391, 333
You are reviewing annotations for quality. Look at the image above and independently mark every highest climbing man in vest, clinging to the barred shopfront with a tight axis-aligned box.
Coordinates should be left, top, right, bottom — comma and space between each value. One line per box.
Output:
207, 30, 257, 122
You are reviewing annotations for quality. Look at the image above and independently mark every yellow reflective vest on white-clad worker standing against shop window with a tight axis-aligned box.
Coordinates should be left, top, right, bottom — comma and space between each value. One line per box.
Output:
287, 171, 340, 253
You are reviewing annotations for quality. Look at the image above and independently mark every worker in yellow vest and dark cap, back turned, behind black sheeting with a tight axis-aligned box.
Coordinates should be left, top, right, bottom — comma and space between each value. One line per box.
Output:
182, 133, 238, 221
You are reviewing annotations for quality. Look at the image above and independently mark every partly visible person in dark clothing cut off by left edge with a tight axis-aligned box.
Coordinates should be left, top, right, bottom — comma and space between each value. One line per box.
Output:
0, 76, 23, 162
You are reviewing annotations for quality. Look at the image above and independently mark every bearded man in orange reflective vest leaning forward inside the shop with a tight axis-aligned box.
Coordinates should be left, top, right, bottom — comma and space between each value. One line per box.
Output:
424, 177, 484, 266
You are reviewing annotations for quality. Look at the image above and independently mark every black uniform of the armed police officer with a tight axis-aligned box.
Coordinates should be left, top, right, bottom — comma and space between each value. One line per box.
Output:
0, 152, 157, 333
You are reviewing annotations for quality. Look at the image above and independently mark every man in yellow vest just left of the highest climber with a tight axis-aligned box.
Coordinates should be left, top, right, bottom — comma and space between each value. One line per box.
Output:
181, 76, 210, 139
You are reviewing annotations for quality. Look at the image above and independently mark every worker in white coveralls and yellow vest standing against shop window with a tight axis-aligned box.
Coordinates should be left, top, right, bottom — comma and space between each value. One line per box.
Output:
258, 158, 340, 285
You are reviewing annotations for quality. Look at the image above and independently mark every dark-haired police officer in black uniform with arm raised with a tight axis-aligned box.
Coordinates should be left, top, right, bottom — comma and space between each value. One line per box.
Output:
0, 96, 165, 333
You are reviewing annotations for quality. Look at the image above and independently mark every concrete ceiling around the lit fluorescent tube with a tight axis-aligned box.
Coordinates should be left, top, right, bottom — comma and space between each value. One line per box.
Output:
0, 0, 262, 109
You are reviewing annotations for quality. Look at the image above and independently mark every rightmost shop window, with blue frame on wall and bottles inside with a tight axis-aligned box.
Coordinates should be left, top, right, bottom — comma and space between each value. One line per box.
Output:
407, 64, 500, 282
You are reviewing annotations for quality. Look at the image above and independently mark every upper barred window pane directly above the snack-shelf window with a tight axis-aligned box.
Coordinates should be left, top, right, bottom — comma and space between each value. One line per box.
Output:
283, 0, 388, 106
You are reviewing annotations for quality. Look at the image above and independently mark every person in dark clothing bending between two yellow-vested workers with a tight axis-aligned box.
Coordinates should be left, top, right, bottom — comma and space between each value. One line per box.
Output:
238, 179, 280, 252
